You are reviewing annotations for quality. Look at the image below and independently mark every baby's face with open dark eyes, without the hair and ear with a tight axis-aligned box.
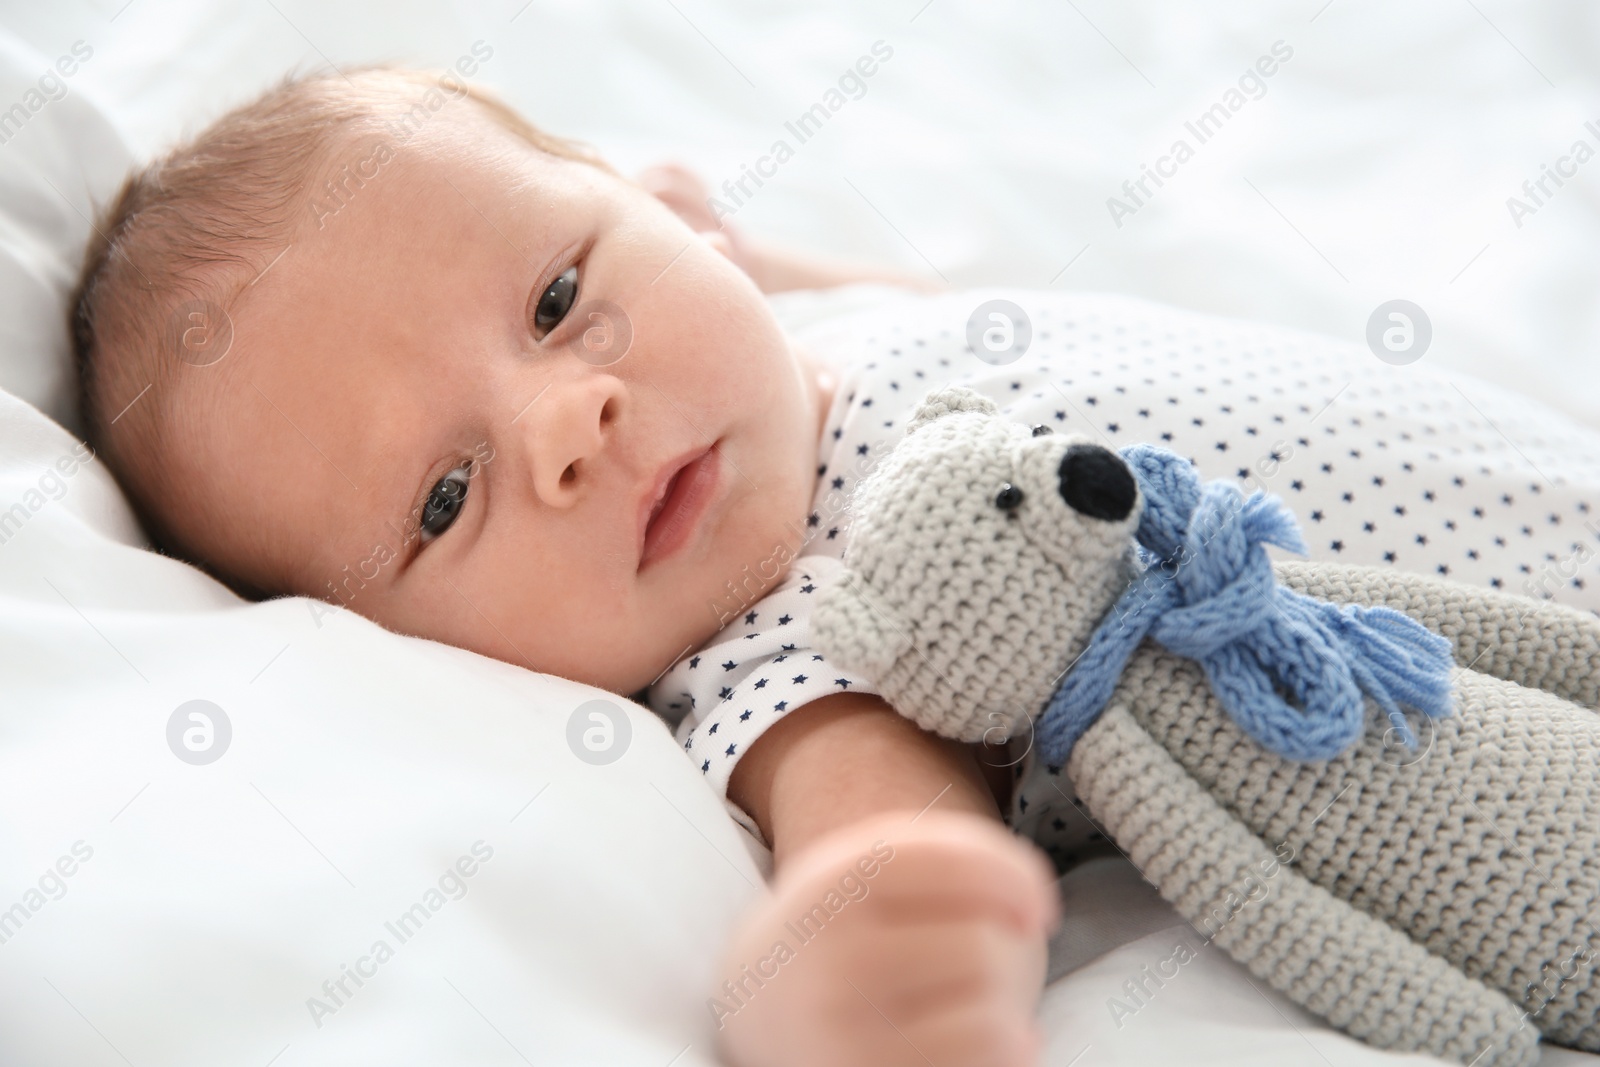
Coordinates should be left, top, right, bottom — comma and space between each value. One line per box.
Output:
187, 116, 821, 694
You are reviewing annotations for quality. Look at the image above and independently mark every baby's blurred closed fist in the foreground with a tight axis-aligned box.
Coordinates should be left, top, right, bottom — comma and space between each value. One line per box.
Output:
712, 811, 1059, 1067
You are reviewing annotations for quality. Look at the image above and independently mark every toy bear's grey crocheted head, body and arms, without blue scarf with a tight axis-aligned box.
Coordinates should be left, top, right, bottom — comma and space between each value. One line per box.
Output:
811, 386, 1600, 1067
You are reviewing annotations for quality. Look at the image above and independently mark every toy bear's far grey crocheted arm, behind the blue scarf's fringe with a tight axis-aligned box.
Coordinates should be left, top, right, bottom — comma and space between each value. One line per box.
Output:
1275, 560, 1600, 707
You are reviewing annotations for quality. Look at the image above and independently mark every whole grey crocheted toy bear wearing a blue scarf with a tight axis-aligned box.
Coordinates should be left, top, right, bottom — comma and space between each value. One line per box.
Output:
811, 386, 1600, 1067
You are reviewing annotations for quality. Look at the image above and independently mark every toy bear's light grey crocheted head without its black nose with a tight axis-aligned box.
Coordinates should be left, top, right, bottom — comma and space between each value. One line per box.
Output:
811, 386, 1139, 741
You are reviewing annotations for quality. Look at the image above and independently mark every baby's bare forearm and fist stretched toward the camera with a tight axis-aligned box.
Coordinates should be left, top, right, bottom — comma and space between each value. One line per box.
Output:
722, 693, 1056, 1067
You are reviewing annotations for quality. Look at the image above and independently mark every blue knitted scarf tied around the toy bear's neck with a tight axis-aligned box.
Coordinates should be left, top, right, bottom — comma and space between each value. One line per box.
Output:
1037, 445, 1451, 766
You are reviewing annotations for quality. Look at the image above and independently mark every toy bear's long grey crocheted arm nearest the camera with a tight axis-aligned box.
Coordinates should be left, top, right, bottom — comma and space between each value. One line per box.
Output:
1067, 702, 1539, 1067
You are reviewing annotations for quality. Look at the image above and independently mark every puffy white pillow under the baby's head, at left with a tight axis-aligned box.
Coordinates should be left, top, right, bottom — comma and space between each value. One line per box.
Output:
0, 34, 762, 1067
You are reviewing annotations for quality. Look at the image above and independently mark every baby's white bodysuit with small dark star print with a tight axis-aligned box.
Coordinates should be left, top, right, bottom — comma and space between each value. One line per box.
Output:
648, 290, 1600, 865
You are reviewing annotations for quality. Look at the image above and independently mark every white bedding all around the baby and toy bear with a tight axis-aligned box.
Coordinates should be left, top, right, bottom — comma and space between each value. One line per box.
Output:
0, 0, 1600, 1067
